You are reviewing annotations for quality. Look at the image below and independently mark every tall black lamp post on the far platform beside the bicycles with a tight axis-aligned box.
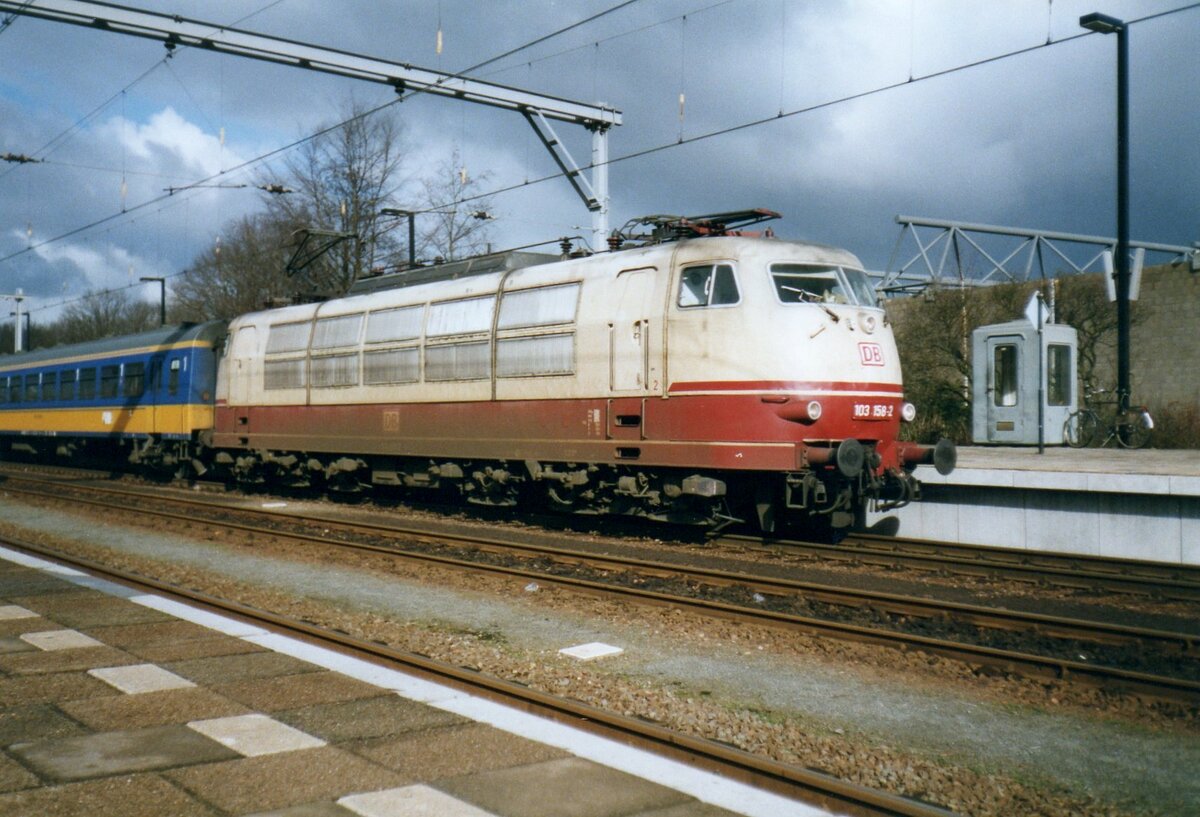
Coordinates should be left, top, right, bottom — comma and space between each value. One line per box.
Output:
1079, 12, 1132, 410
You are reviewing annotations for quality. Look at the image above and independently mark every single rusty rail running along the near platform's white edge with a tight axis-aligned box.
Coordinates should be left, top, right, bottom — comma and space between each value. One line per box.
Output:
0, 537, 953, 817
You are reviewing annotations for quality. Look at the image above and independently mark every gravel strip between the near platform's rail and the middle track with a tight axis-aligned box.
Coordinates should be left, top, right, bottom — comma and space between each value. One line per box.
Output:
0, 495, 1200, 817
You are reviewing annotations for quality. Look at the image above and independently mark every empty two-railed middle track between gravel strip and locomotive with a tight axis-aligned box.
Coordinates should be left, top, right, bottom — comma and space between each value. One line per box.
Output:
5, 472, 1200, 705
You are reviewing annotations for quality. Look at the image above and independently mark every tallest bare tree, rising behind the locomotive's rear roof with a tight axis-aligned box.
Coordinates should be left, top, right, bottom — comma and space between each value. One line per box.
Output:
268, 98, 406, 294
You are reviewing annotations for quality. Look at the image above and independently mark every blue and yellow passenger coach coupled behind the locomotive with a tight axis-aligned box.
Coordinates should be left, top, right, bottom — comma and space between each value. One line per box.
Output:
0, 322, 226, 468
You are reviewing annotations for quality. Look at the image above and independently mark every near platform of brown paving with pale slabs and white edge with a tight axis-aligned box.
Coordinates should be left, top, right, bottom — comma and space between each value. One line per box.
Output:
0, 548, 826, 817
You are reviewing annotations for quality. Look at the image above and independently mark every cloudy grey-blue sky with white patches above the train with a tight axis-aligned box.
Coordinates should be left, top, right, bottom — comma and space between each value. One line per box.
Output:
0, 0, 1200, 322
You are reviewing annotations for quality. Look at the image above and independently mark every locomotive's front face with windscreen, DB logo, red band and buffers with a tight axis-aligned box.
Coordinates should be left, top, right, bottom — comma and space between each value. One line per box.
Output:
760, 252, 955, 530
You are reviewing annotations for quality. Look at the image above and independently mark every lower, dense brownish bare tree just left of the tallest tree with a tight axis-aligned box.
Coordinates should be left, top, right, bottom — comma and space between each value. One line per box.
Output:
169, 214, 299, 322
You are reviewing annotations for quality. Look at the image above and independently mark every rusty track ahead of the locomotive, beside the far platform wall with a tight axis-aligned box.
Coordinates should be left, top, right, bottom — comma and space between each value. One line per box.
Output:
721, 534, 1200, 602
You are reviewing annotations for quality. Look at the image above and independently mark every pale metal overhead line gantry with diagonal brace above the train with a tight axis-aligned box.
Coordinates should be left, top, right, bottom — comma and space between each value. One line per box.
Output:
0, 0, 622, 251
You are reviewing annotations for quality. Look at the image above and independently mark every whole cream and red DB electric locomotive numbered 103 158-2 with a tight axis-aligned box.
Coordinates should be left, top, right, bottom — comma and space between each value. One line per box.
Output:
208, 211, 954, 530
